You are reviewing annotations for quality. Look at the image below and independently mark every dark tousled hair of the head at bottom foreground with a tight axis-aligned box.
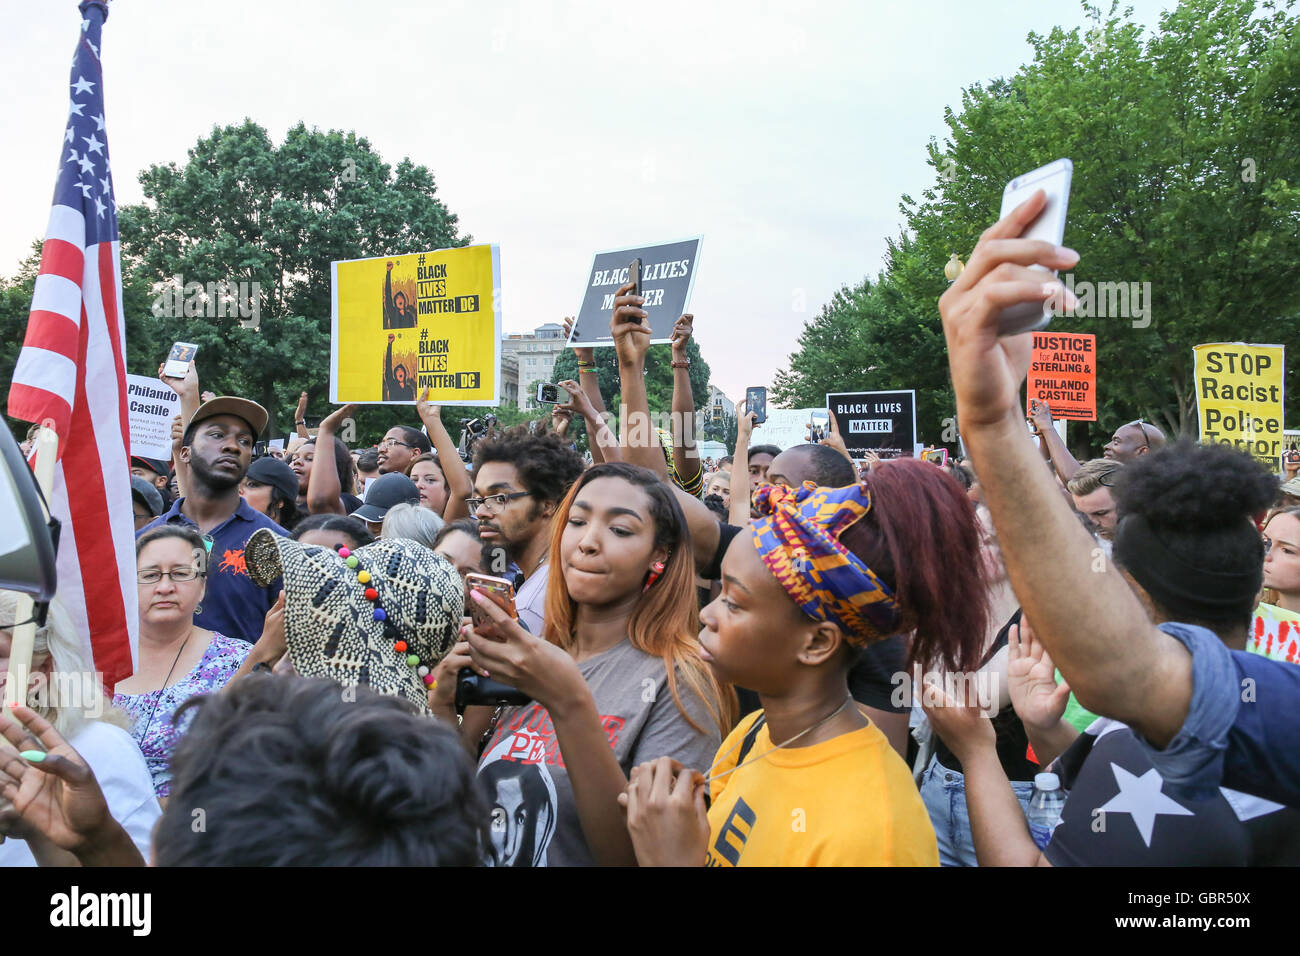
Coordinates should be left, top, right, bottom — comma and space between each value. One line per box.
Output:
153, 674, 490, 866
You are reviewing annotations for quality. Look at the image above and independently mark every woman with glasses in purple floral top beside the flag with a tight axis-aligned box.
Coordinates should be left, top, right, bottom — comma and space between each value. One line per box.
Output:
113, 524, 250, 803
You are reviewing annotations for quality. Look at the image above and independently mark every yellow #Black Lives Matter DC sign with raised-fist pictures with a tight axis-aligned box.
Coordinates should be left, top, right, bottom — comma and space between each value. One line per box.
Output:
330, 246, 501, 406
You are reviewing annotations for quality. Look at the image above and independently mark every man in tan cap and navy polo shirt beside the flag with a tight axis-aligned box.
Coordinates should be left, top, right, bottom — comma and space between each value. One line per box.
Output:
138, 397, 286, 643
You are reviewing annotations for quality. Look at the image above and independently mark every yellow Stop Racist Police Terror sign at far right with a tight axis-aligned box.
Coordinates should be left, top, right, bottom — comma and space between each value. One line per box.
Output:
1192, 342, 1284, 468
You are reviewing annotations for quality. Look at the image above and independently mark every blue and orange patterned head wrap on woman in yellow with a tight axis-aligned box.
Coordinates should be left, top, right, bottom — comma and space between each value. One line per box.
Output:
750, 481, 902, 645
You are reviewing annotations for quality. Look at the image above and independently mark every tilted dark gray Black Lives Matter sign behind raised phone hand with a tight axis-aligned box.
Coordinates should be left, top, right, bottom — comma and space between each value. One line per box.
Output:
569, 235, 703, 346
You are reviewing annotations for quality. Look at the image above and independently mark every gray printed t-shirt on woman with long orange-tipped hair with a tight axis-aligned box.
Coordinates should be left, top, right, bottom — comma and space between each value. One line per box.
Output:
478, 639, 722, 866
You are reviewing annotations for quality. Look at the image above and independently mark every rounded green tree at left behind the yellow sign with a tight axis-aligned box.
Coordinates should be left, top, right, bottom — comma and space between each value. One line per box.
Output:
120, 120, 469, 442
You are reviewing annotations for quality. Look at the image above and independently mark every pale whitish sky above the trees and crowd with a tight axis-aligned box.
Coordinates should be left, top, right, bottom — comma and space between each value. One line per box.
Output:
0, 0, 1173, 399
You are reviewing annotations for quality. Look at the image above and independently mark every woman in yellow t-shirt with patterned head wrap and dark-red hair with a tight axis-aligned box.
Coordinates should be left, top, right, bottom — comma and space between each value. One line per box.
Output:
620, 459, 988, 866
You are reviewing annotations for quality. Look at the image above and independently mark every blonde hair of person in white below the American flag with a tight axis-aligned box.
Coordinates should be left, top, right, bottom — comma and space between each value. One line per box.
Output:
0, 589, 130, 740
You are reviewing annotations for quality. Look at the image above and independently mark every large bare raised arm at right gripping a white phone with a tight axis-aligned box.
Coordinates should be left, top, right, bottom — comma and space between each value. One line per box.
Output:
939, 191, 1192, 747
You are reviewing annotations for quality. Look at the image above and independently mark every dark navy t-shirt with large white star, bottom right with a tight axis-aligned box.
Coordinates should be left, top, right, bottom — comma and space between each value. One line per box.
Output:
1044, 718, 1300, 866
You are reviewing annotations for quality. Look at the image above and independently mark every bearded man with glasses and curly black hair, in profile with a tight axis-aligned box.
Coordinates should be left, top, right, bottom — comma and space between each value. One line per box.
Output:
467, 433, 585, 636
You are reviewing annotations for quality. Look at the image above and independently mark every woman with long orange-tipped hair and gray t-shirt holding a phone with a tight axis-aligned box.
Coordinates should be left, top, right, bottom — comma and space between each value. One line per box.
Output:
430, 463, 735, 866
